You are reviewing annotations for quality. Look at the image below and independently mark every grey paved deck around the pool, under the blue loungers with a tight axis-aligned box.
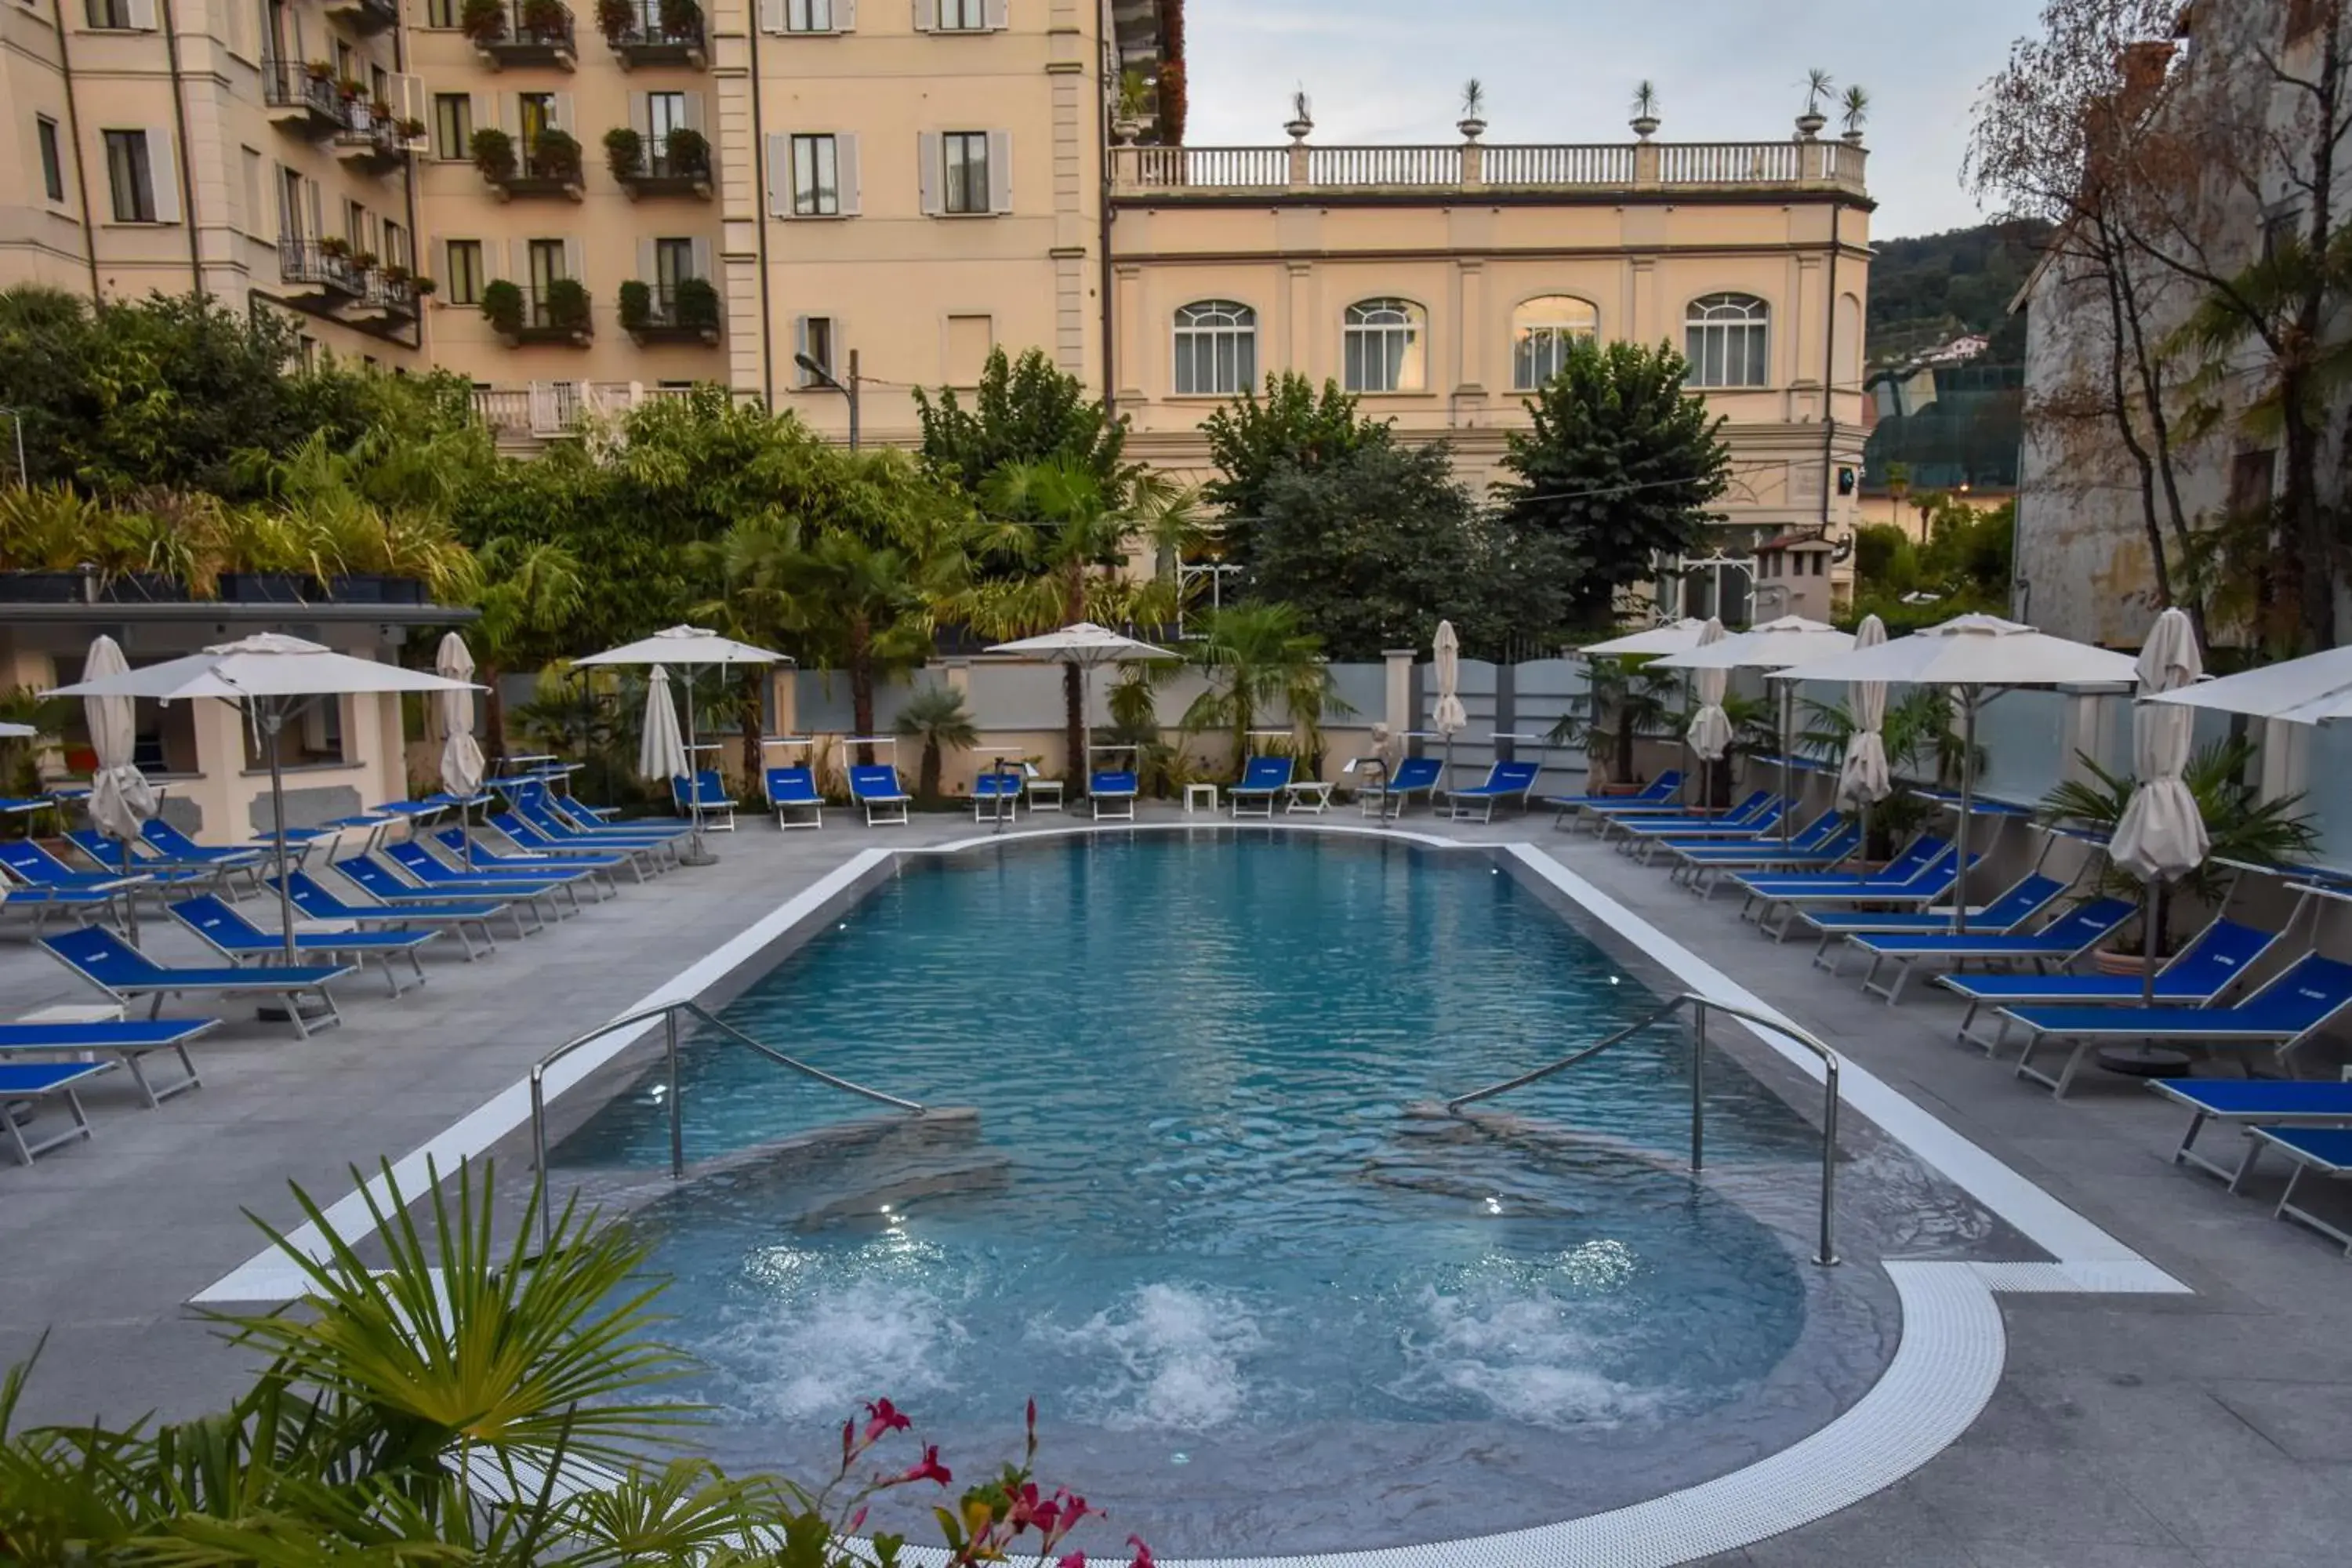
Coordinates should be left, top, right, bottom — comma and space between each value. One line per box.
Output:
0, 806, 2352, 1568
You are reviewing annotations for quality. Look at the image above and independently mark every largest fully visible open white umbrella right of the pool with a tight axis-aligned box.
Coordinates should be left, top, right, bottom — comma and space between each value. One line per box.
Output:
1771, 616, 2136, 931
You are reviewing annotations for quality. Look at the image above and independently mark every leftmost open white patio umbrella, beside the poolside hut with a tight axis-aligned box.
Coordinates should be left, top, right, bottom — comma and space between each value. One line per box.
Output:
42, 633, 477, 964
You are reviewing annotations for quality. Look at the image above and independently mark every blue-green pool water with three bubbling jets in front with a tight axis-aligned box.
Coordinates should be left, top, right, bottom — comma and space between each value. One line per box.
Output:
560, 834, 1811, 1549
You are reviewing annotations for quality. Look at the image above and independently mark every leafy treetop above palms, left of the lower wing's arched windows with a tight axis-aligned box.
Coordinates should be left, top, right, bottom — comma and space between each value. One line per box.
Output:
915, 348, 1136, 496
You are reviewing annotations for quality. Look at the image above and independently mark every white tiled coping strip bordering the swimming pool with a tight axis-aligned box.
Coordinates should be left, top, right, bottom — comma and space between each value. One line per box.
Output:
193, 818, 2187, 1568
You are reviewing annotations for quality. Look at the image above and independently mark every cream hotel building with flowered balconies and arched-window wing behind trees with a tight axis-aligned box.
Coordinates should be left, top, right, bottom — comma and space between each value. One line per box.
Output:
0, 0, 1870, 609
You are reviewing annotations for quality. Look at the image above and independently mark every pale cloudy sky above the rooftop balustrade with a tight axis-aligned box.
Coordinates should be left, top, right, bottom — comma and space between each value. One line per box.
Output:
1185, 0, 2042, 240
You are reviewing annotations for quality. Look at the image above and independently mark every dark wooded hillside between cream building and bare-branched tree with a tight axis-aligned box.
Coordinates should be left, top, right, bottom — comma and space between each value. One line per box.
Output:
1865, 223, 2049, 365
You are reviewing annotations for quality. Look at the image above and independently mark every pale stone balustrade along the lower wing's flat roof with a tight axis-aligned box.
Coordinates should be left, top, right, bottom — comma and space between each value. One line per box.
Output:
1110, 139, 1870, 205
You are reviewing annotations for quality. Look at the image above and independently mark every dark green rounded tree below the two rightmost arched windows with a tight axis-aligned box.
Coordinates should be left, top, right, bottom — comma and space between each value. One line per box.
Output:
1494, 339, 1731, 626
